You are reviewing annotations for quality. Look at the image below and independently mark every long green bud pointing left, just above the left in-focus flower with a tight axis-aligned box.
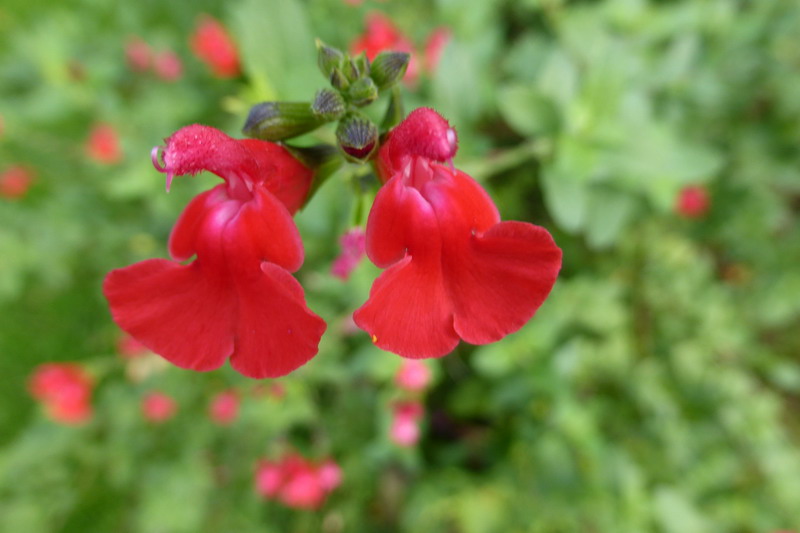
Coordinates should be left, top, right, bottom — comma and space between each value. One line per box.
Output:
242, 102, 326, 141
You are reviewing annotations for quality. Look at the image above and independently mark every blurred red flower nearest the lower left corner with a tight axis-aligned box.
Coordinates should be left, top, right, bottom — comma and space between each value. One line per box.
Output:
28, 363, 92, 425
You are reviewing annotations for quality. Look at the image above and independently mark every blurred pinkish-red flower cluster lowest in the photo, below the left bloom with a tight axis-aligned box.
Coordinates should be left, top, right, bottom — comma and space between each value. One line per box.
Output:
255, 452, 342, 509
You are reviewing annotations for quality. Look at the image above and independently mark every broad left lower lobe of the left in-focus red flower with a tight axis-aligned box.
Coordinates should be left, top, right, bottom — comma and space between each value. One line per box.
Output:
103, 259, 236, 371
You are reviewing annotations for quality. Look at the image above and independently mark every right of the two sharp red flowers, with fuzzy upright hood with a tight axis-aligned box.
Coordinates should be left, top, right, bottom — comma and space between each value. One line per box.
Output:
353, 108, 561, 358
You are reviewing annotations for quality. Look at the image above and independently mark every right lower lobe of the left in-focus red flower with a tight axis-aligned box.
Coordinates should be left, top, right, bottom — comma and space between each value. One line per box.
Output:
231, 262, 326, 379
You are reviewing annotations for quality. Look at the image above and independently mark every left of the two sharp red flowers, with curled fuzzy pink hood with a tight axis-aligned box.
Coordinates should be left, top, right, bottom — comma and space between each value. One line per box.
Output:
103, 125, 325, 378
